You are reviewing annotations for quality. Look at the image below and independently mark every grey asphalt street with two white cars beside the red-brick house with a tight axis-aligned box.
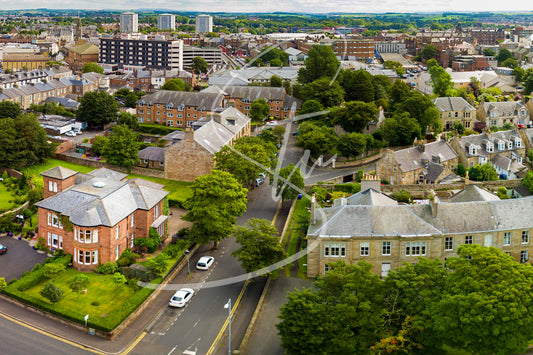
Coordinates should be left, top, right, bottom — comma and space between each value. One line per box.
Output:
130, 184, 278, 355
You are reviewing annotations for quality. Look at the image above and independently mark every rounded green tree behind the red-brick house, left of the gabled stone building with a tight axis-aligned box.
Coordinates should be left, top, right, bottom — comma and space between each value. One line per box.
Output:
102, 126, 140, 171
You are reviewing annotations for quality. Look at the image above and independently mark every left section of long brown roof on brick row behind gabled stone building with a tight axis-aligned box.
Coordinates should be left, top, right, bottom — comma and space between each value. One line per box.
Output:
138, 90, 222, 111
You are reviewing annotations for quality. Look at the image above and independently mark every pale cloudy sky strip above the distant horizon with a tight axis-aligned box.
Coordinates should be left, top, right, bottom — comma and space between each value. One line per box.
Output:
0, 0, 532, 13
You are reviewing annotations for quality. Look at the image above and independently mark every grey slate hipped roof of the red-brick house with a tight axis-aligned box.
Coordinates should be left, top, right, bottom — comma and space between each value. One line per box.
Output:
36, 169, 168, 227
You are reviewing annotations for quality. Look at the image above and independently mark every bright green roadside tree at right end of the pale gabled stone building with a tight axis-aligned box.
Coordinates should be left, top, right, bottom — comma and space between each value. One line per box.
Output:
215, 137, 277, 186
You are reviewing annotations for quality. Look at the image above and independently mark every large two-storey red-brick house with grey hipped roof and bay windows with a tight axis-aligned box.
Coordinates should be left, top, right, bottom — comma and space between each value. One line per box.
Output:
36, 166, 168, 271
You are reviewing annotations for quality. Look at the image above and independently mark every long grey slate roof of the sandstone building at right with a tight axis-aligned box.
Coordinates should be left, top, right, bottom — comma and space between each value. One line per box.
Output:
308, 188, 533, 238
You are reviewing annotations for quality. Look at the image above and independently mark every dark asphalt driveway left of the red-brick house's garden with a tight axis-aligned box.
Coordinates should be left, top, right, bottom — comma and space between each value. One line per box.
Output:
0, 237, 46, 282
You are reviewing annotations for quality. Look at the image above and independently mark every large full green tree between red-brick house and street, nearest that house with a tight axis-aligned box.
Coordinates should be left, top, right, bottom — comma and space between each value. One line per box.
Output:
182, 170, 248, 247
